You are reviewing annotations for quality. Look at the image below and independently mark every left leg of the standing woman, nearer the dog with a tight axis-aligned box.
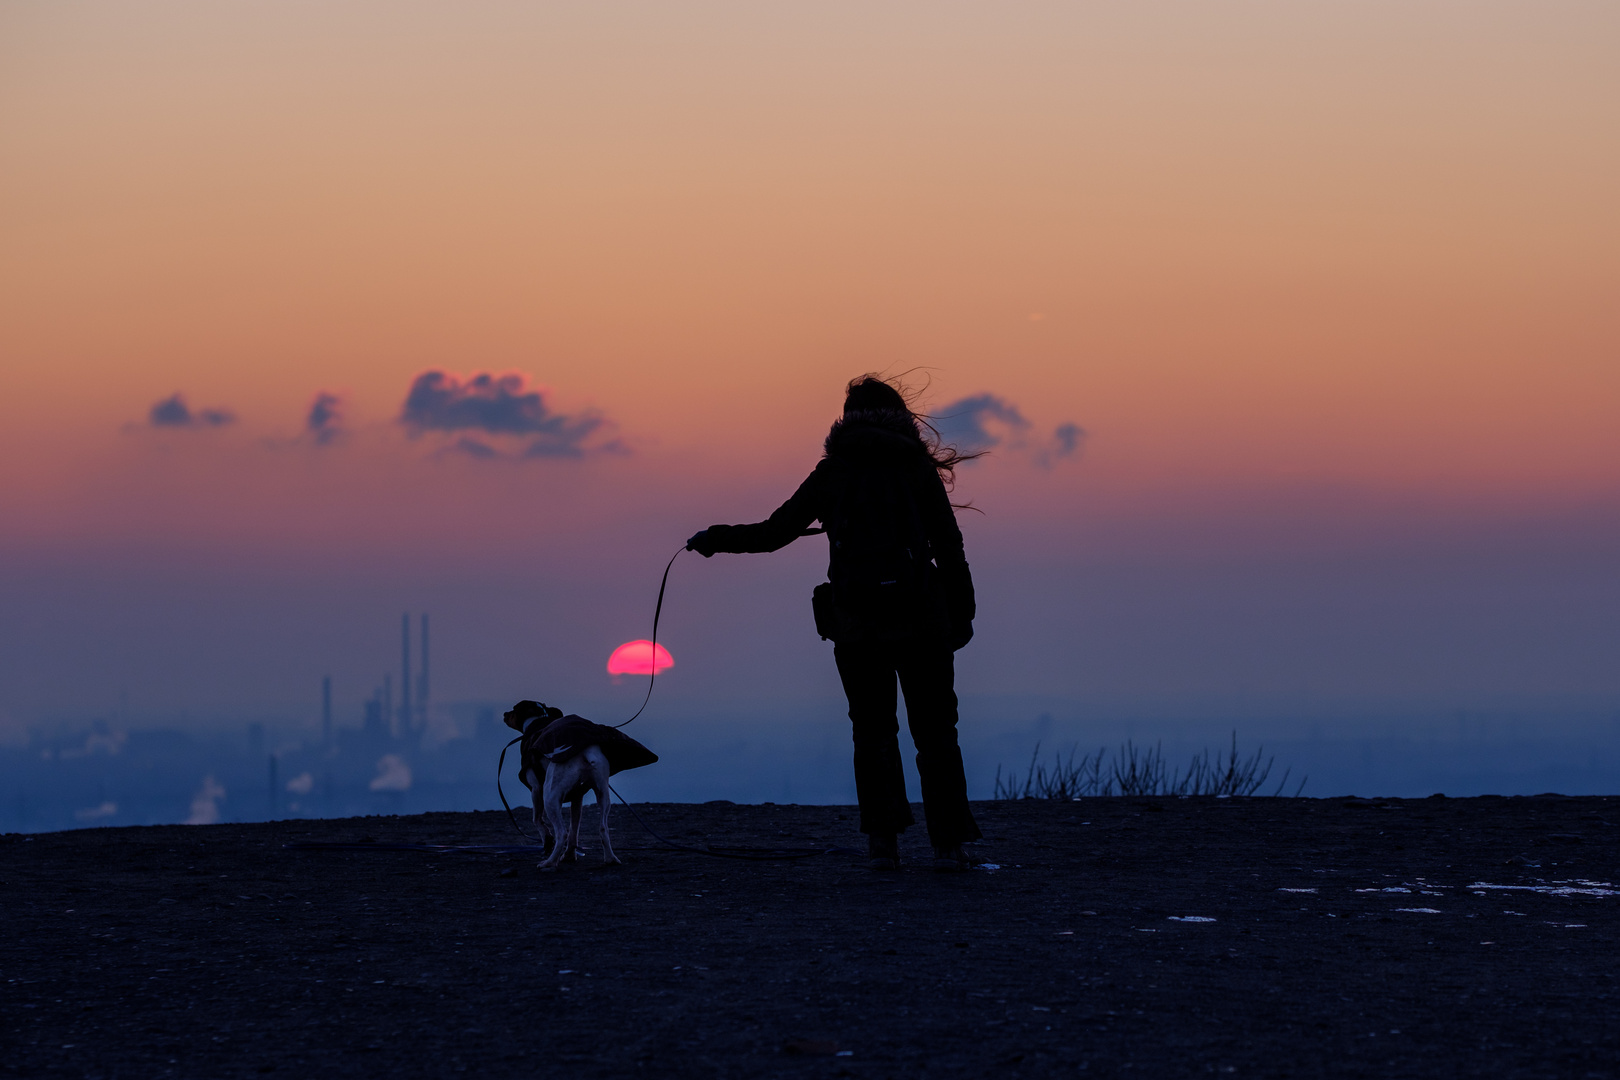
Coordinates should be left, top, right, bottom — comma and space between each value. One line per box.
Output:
833, 644, 917, 836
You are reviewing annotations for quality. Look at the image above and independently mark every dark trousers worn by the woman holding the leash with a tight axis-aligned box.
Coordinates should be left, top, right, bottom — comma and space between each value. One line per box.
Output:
833, 644, 982, 847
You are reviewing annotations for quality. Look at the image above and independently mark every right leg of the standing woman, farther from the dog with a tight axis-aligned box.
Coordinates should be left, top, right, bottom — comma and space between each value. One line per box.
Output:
891, 644, 983, 850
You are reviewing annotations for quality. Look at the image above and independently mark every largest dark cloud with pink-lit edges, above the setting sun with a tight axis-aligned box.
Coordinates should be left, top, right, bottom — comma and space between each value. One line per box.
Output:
400, 371, 627, 458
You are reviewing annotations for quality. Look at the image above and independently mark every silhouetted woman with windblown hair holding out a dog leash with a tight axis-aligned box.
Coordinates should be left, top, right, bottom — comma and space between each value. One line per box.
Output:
687, 376, 980, 870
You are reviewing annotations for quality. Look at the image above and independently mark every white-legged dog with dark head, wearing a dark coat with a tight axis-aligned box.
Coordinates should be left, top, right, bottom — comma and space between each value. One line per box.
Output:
504, 701, 658, 870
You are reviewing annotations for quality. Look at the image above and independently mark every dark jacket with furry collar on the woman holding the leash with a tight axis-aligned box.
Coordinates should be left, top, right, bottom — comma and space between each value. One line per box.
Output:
706, 411, 975, 648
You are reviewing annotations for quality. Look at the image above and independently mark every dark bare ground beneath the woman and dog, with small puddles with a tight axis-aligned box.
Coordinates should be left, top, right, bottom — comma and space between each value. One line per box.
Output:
0, 797, 1620, 1078
